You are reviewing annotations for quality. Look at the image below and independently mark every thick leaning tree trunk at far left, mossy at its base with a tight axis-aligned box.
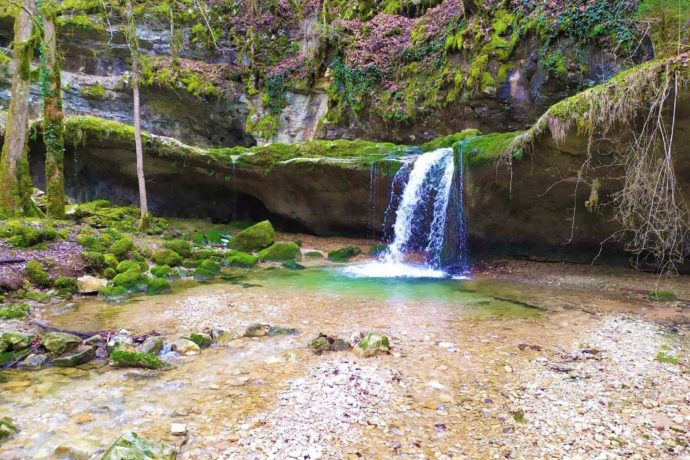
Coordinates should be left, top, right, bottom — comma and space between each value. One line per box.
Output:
0, 0, 38, 215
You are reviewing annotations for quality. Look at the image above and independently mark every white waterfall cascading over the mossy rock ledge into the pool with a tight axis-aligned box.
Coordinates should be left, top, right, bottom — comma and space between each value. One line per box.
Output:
346, 148, 467, 278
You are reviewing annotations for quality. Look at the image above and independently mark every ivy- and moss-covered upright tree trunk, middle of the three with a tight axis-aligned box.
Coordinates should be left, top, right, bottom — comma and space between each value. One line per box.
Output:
41, 4, 65, 219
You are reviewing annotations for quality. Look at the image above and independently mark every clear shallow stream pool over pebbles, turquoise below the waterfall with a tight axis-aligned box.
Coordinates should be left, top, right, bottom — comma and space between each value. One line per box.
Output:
0, 266, 680, 458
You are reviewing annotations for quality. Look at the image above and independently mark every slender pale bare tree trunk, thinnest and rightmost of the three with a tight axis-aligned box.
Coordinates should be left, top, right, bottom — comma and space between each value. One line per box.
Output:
127, 0, 149, 231
